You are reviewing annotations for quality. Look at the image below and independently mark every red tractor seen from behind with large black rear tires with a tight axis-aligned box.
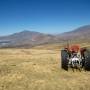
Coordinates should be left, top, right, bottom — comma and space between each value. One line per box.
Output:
61, 45, 90, 71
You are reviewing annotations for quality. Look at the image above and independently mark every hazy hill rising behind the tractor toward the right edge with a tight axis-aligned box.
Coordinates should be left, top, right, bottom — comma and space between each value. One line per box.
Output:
56, 25, 90, 42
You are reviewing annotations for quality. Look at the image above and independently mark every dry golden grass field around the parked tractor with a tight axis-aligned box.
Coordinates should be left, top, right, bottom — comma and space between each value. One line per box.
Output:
0, 48, 90, 90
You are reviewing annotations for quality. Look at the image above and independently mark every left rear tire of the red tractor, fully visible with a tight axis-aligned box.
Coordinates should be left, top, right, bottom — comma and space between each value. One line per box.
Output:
61, 50, 69, 71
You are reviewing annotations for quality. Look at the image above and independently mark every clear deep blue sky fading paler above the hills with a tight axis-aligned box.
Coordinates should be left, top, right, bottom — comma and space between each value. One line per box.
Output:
0, 0, 90, 35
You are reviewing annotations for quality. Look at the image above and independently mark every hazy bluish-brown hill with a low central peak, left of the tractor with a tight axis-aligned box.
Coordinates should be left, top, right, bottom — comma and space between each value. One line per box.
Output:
0, 30, 55, 47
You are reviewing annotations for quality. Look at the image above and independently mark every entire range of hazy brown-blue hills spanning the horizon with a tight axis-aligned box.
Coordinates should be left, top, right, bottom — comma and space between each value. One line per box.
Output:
0, 25, 90, 47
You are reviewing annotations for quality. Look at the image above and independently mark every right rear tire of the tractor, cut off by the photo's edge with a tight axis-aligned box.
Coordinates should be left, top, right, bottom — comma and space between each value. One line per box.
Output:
84, 50, 90, 71
